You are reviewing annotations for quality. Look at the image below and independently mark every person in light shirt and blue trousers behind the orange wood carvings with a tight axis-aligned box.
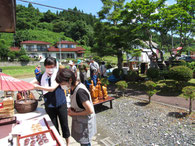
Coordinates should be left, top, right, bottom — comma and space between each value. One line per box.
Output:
90, 59, 99, 86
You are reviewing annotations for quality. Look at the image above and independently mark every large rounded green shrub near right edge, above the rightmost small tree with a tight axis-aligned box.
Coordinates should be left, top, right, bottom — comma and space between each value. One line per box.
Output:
169, 66, 193, 82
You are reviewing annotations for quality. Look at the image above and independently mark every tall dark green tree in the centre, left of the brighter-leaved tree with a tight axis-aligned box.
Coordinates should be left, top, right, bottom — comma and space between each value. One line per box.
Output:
94, 0, 140, 69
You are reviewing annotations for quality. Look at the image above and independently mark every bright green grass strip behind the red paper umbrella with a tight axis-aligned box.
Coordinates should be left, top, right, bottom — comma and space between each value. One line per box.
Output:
0, 66, 35, 78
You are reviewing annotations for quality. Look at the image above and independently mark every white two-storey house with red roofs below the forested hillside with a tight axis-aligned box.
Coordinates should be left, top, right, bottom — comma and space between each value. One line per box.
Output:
21, 41, 85, 59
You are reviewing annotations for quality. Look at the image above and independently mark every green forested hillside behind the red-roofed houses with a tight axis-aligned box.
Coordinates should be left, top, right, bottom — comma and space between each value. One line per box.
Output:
0, 4, 97, 47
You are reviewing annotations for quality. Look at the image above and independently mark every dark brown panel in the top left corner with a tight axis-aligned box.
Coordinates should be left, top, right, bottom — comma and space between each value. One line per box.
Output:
0, 0, 16, 32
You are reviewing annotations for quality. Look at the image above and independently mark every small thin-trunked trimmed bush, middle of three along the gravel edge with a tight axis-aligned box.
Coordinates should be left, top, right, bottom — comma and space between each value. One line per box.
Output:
144, 81, 157, 103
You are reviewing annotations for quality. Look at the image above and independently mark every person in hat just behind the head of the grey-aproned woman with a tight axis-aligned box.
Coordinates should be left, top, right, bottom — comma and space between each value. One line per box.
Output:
77, 60, 87, 84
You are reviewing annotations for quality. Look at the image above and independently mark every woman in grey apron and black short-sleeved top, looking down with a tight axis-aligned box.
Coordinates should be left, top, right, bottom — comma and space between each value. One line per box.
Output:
56, 69, 97, 146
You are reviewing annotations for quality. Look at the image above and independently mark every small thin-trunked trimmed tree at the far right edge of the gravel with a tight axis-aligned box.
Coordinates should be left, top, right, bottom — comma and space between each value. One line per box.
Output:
182, 86, 195, 114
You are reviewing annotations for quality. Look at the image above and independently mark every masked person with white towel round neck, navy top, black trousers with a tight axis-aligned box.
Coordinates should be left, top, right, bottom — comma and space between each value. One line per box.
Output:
31, 57, 70, 146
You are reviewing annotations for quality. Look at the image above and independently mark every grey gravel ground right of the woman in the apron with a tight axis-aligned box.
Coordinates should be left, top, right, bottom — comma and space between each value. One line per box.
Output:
96, 97, 195, 146
